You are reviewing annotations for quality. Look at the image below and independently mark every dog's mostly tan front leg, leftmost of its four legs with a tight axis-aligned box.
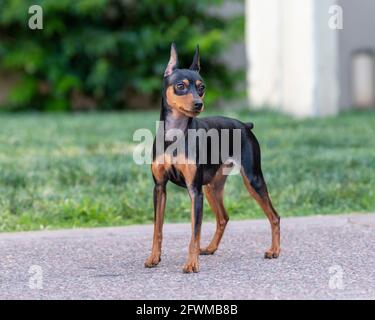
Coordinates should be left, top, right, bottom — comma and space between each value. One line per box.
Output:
145, 183, 167, 268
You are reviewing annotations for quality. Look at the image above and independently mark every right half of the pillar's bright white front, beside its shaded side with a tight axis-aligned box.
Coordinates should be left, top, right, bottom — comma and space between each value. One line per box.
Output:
280, 0, 317, 116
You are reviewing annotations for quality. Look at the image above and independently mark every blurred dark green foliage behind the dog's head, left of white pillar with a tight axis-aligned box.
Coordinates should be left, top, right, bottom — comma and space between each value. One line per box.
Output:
0, 0, 244, 111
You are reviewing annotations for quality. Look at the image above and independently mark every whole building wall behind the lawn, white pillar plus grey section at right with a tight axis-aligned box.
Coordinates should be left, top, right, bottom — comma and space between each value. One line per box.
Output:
246, 0, 375, 116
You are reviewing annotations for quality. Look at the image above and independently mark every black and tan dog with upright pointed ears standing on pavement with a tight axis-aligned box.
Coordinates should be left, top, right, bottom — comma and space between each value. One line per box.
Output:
145, 44, 280, 273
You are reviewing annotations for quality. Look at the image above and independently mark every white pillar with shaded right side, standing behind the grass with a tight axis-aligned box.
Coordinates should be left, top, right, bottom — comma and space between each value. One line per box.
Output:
246, 0, 338, 117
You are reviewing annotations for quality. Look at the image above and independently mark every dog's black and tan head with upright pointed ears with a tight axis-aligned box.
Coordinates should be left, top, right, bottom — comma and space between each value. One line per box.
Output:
164, 43, 205, 117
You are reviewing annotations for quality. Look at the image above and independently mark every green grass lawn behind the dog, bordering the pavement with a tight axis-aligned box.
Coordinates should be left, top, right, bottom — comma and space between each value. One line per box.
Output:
0, 111, 375, 231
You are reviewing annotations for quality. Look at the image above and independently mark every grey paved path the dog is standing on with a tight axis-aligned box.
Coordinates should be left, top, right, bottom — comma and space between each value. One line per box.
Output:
0, 214, 375, 299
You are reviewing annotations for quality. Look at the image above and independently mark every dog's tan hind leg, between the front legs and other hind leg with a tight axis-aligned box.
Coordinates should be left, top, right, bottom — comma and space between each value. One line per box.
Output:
200, 169, 229, 255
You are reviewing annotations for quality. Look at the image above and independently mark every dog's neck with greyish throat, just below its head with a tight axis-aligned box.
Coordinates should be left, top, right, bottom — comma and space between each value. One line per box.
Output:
160, 98, 192, 139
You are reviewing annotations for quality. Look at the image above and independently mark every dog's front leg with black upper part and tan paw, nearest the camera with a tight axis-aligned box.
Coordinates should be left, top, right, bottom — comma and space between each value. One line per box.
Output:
183, 187, 203, 273
